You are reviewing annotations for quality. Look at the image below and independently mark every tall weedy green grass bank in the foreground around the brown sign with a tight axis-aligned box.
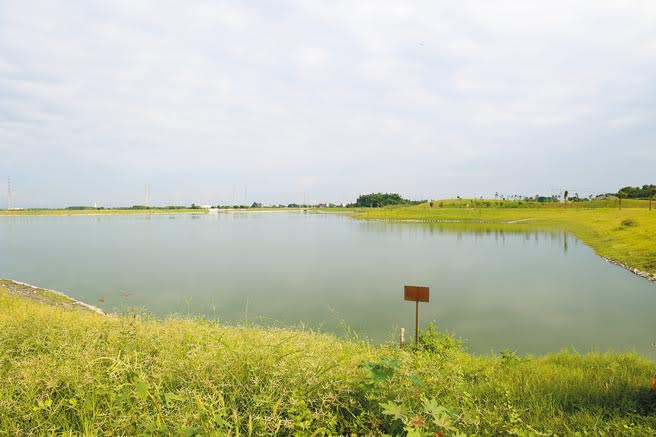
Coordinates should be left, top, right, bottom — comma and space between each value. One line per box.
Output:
0, 282, 656, 436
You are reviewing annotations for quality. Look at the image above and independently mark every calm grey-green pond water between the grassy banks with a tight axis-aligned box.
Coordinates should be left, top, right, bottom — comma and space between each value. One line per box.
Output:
0, 213, 656, 358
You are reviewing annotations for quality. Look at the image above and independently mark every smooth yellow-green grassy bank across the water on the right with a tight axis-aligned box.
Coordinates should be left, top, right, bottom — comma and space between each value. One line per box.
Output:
355, 199, 656, 274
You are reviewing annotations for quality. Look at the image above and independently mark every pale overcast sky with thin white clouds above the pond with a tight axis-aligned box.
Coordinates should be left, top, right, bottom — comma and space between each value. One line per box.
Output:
0, 0, 656, 208
